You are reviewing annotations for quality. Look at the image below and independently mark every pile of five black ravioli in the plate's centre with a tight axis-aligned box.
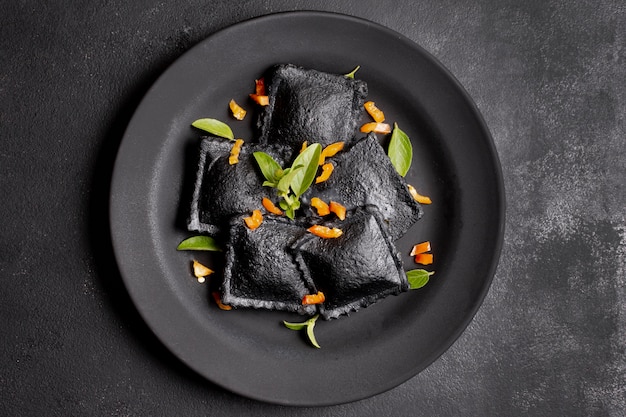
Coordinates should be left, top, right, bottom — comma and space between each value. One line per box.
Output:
188, 64, 422, 319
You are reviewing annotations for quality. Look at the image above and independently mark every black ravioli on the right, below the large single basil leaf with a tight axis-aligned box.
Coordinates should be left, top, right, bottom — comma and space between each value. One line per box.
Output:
303, 134, 422, 240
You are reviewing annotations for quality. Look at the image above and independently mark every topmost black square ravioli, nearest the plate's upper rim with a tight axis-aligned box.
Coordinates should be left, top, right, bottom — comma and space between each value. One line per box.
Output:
259, 64, 367, 146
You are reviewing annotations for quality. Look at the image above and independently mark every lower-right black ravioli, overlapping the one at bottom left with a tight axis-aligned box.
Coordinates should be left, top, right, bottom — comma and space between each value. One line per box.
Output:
293, 206, 409, 319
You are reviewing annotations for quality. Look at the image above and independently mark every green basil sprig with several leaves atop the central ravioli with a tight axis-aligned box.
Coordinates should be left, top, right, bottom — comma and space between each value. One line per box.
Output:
253, 143, 322, 219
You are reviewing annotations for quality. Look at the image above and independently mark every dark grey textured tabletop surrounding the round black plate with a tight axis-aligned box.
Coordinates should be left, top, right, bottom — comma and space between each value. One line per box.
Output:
0, 0, 626, 416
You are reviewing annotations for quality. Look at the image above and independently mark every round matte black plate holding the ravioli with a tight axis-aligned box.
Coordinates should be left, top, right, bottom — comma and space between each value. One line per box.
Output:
110, 12, 504, 405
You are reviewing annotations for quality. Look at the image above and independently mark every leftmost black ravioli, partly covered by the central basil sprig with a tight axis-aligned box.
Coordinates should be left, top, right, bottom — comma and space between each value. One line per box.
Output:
187, 136, 289, 235
